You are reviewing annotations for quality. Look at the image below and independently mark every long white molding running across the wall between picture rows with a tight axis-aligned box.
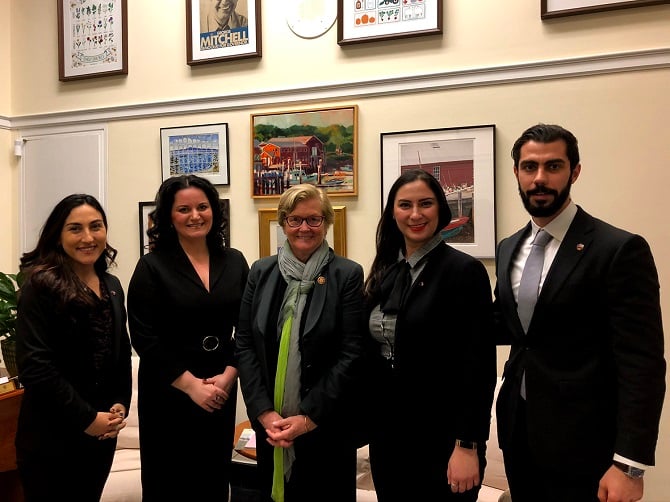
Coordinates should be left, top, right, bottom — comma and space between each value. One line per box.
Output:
3, 47, 670, 130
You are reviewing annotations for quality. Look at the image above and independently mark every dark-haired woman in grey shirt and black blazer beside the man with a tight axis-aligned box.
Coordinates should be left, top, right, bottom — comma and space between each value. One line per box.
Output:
365, 169, 496, 502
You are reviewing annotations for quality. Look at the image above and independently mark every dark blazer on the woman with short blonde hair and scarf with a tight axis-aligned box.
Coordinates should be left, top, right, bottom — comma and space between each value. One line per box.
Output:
236, 250, 365, 431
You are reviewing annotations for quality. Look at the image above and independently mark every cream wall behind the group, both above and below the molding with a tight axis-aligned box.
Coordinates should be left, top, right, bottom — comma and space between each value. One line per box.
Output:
5, 0, 670, 502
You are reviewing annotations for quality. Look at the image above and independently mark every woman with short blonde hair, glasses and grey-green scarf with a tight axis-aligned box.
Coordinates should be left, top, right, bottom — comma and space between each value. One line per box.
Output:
236, 184, 364, 502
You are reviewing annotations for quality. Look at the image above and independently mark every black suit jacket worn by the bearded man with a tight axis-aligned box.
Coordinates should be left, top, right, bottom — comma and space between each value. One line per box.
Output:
495, 208, 665, 468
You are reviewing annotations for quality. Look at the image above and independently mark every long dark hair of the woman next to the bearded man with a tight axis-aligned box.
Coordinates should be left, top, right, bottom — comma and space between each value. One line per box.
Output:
365, 169, 451, 301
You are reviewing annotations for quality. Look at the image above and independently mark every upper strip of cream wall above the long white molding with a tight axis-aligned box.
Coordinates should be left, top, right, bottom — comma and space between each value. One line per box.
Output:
5, 0, 670, 116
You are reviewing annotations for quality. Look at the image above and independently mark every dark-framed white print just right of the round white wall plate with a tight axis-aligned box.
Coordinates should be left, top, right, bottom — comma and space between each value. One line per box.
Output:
337, 0, 442, 45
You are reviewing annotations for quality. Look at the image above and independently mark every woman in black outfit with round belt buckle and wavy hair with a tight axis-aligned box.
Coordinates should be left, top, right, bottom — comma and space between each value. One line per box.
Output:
128, 175, 249, 502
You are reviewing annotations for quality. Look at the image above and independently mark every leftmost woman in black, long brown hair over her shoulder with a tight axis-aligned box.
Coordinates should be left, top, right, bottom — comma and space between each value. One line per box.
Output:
16, 194, 131, 502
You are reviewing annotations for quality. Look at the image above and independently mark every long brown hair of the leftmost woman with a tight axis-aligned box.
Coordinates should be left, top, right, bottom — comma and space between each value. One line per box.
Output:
19, 193, 117, 304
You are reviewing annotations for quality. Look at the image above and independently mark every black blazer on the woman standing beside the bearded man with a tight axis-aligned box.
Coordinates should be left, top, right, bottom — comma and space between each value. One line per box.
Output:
368, 244, 496, 450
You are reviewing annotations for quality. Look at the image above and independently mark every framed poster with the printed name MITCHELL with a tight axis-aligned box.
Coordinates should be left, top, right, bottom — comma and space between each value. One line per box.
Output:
186, 0, 261, 66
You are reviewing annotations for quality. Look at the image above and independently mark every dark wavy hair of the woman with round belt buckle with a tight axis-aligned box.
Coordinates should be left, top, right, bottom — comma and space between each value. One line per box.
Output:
147, 174, 227, 251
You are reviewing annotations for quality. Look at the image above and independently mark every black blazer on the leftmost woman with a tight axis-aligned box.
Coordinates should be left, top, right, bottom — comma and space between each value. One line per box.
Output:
16, 274, 131, 459
